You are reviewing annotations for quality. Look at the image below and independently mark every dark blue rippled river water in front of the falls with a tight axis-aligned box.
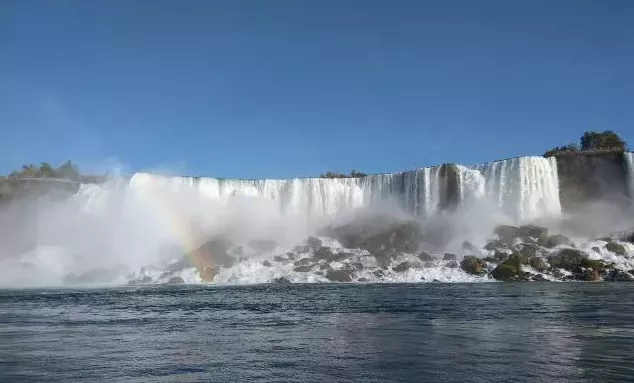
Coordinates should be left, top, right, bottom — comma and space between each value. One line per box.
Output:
0, 283, 634, 383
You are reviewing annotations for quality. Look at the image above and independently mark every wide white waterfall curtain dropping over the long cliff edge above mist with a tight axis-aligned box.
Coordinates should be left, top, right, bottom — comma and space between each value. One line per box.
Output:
71, 154, 556, 225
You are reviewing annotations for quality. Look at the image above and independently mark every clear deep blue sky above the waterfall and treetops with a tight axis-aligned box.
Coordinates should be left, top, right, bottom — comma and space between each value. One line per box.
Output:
0, 0, 634, 178
